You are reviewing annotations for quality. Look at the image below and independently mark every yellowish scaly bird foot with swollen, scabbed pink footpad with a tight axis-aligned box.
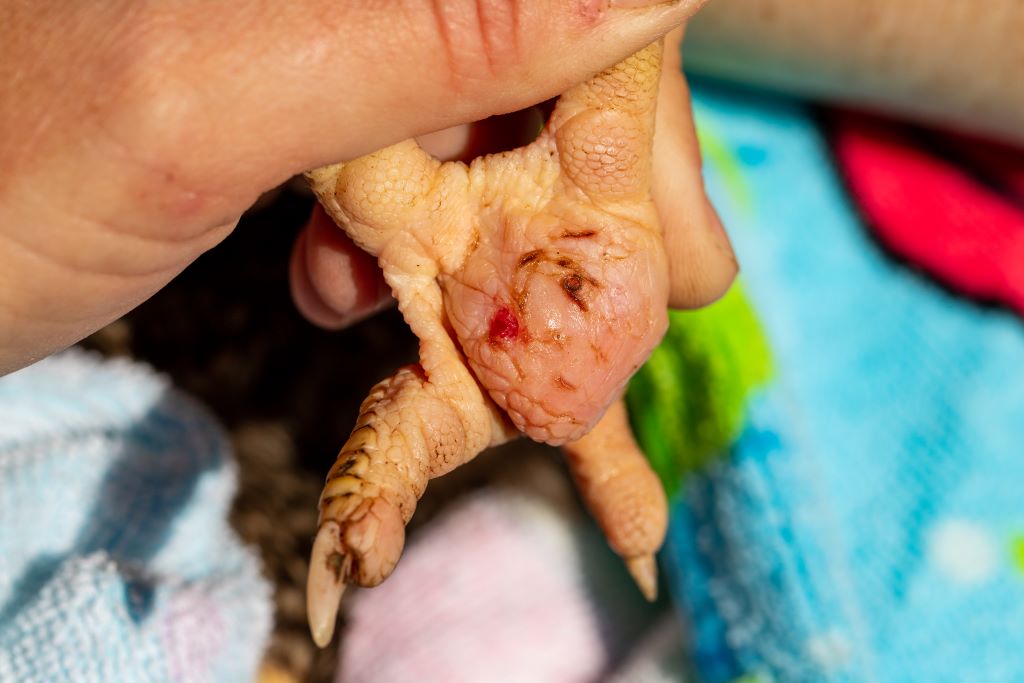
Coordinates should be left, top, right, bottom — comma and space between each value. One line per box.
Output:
307, 43, 669, 645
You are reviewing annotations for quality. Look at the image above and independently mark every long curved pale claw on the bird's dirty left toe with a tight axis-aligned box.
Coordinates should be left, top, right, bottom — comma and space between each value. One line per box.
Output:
306, 521, 351, 647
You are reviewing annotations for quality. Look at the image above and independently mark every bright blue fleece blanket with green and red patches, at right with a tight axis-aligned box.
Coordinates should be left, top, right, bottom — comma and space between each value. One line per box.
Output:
630, 86, 1024, 683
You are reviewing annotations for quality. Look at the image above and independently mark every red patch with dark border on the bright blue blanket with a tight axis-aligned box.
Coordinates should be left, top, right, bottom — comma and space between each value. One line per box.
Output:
829, 113, 1024, 313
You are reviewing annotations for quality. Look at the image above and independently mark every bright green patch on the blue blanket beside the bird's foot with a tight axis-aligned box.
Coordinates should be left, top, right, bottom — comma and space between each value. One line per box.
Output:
626, 283, 771, 496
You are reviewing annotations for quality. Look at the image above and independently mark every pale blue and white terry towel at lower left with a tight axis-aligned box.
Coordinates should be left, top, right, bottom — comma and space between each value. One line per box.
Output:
0, 351, 271, 683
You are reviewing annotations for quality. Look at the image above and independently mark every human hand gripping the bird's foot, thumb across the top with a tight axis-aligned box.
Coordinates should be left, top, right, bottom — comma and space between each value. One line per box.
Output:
0, 0, 735, 373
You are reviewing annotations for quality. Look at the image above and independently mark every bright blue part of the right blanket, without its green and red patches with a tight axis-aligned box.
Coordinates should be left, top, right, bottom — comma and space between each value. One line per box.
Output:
647, 84, 1024, 683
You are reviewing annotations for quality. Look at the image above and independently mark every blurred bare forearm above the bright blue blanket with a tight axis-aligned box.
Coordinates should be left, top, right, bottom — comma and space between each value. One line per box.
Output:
687, 0, 1024, 143
